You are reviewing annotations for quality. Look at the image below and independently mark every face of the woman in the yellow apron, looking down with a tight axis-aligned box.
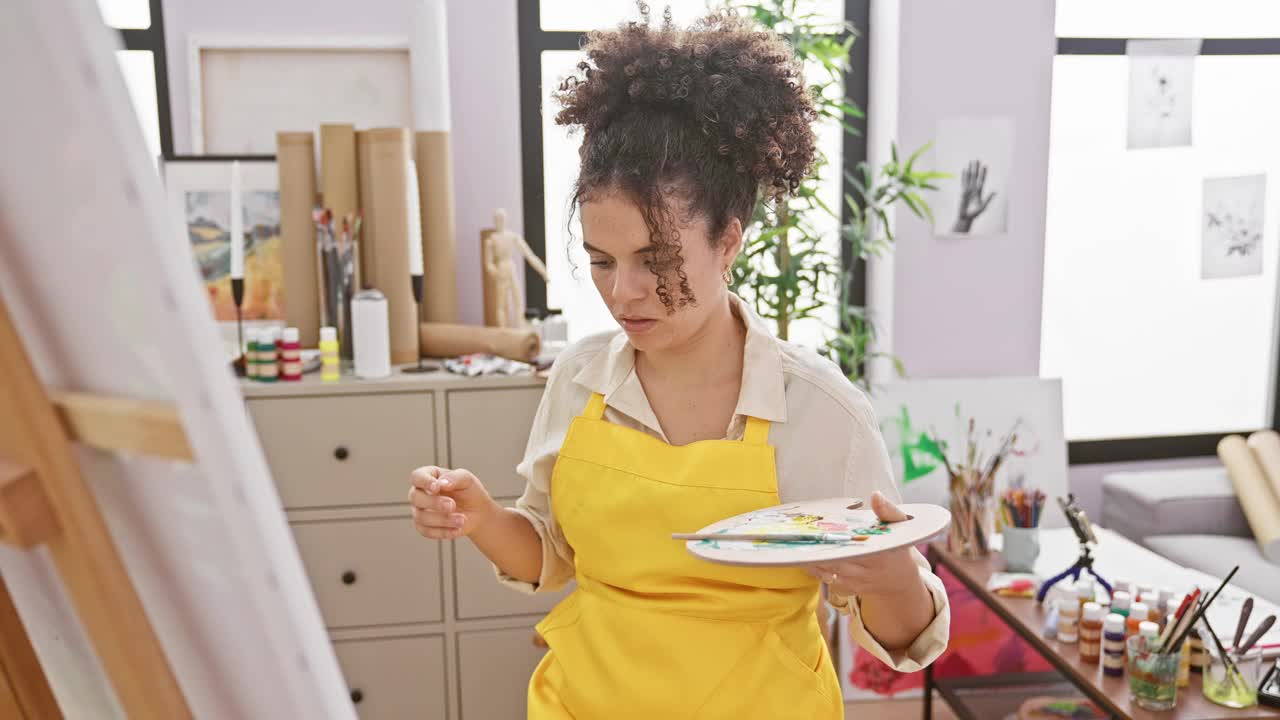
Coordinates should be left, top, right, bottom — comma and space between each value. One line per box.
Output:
582, 192, 742, 352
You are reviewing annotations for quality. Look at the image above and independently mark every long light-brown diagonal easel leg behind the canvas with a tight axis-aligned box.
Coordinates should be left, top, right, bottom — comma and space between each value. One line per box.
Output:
0, 286, 191, 720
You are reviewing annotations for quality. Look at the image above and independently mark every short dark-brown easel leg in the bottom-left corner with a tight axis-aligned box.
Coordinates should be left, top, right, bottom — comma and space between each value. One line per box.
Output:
0, 575, 63, 720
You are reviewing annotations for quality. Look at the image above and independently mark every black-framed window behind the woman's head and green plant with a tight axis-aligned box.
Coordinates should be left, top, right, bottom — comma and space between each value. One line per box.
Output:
518, 0, 867, 346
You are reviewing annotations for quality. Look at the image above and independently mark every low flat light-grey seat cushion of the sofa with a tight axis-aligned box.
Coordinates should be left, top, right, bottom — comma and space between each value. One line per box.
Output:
1142, 534, 1280, 605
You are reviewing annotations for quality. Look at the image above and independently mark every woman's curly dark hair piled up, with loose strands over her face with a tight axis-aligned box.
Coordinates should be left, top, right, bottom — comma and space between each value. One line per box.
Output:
553, 3, 818, 313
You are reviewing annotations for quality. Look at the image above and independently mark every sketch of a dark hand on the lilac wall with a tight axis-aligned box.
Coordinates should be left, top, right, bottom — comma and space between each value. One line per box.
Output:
934, 117, 1014, 237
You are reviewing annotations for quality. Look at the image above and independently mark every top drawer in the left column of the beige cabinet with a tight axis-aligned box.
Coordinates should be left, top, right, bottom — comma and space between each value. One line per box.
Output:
248, 393, 435, 509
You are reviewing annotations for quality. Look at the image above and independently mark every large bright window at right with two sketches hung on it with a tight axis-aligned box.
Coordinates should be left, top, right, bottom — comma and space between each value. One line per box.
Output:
1041, 0, 1280, 462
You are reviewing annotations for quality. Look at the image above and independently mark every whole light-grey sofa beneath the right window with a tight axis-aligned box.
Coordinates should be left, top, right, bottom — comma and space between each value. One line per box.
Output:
1100, 466, 1280, 605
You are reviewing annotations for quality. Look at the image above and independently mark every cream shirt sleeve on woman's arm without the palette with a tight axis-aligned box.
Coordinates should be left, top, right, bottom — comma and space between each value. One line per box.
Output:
494, 363, 588, 594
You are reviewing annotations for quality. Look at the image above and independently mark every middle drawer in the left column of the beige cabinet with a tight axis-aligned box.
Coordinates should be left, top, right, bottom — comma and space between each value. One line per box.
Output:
292, 512, 444, 628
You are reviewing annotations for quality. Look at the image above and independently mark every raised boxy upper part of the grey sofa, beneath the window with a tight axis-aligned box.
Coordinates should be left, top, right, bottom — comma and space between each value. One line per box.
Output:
1101, 465, 1253, 542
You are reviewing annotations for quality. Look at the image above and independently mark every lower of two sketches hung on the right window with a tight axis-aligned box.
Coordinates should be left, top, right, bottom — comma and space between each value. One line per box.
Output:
1201, 176, 1267, 279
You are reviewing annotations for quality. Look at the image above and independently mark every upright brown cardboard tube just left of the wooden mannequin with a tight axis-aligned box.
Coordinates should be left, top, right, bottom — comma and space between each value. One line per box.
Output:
416, 131, 458, 323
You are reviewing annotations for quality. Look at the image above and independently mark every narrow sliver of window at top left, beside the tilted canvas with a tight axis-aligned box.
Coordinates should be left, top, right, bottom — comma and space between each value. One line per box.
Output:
97, 0, 173, 163
